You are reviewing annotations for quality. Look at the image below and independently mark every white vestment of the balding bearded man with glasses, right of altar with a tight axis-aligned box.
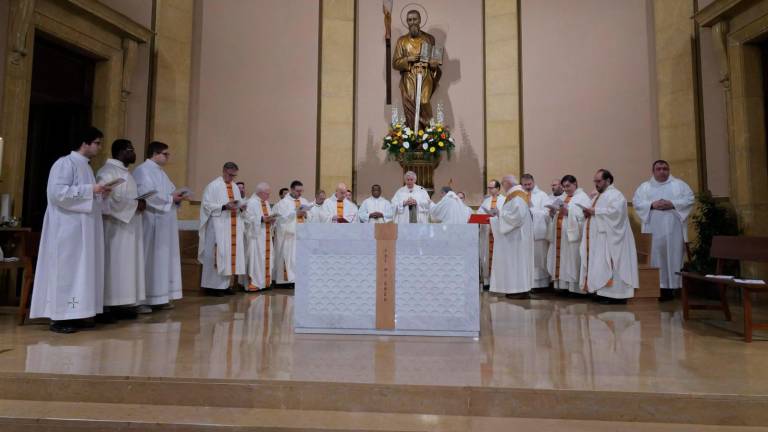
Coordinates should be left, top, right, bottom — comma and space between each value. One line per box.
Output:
579, 185, 640, 299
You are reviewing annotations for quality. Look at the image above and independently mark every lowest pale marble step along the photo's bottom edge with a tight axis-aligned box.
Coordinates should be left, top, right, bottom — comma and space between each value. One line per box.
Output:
0, 400, 766, 432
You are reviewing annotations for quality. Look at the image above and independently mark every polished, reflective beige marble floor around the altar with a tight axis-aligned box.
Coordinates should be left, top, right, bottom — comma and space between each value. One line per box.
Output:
0, 290, 768, 395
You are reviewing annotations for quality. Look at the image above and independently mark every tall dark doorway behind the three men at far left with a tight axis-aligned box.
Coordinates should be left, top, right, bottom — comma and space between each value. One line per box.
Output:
22, 36, 95, 231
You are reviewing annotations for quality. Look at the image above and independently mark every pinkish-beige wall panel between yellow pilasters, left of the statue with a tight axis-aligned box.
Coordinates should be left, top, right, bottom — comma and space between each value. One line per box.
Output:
190, 0, 320, 198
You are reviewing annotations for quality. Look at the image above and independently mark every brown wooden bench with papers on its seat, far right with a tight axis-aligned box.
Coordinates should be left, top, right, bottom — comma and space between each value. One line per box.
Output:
681, 236, 768, 342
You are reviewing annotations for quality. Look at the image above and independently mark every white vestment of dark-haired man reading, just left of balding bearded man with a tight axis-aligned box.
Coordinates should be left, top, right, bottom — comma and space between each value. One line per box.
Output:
547, 188, 592, 293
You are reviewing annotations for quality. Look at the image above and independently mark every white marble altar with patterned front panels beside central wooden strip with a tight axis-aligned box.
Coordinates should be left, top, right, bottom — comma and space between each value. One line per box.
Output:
294, 224, 480, 337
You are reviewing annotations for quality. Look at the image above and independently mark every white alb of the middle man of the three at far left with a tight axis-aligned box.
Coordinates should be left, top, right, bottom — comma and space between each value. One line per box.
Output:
96, 159, 146, 306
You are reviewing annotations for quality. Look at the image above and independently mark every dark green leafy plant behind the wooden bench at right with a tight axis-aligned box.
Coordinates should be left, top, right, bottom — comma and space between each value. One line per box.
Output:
688, 191, 739, 273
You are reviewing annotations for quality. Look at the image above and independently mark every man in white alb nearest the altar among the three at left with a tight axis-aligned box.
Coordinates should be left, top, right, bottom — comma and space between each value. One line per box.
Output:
133, 141, 189, 313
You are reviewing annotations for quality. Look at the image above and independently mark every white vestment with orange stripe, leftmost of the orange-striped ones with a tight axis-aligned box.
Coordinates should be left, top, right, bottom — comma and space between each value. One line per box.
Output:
197, 177, 246, 290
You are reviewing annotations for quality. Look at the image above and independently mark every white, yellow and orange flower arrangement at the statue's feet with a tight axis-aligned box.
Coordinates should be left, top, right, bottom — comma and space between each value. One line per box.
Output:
381, 122, 456, 160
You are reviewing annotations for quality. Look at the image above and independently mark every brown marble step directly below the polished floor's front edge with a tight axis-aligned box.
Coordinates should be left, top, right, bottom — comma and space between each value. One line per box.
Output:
0, 373, 768, 430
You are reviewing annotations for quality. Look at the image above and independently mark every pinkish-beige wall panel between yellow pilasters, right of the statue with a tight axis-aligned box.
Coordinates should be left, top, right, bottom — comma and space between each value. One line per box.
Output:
521, 0, 660, 199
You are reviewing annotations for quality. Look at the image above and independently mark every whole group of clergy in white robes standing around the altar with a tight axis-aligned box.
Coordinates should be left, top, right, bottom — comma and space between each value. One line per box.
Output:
30, 128, 694, 333
